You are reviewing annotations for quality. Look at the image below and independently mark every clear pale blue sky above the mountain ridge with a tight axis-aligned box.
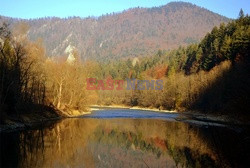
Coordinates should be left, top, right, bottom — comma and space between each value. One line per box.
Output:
0, 0, 250, 19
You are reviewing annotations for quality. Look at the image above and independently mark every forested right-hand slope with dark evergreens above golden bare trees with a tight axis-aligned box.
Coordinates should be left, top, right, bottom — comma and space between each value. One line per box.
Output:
92, 14, 250, 119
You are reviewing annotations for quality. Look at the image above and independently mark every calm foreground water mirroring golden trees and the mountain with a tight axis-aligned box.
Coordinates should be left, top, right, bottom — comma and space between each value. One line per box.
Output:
1, 118, 249, 167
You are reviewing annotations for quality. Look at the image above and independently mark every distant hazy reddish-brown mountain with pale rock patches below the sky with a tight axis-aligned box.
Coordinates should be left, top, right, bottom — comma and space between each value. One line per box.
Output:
2, 2, 230, 60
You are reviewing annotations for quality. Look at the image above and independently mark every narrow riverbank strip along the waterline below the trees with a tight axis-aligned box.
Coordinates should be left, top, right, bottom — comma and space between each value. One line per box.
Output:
0, 105, 250, 132
